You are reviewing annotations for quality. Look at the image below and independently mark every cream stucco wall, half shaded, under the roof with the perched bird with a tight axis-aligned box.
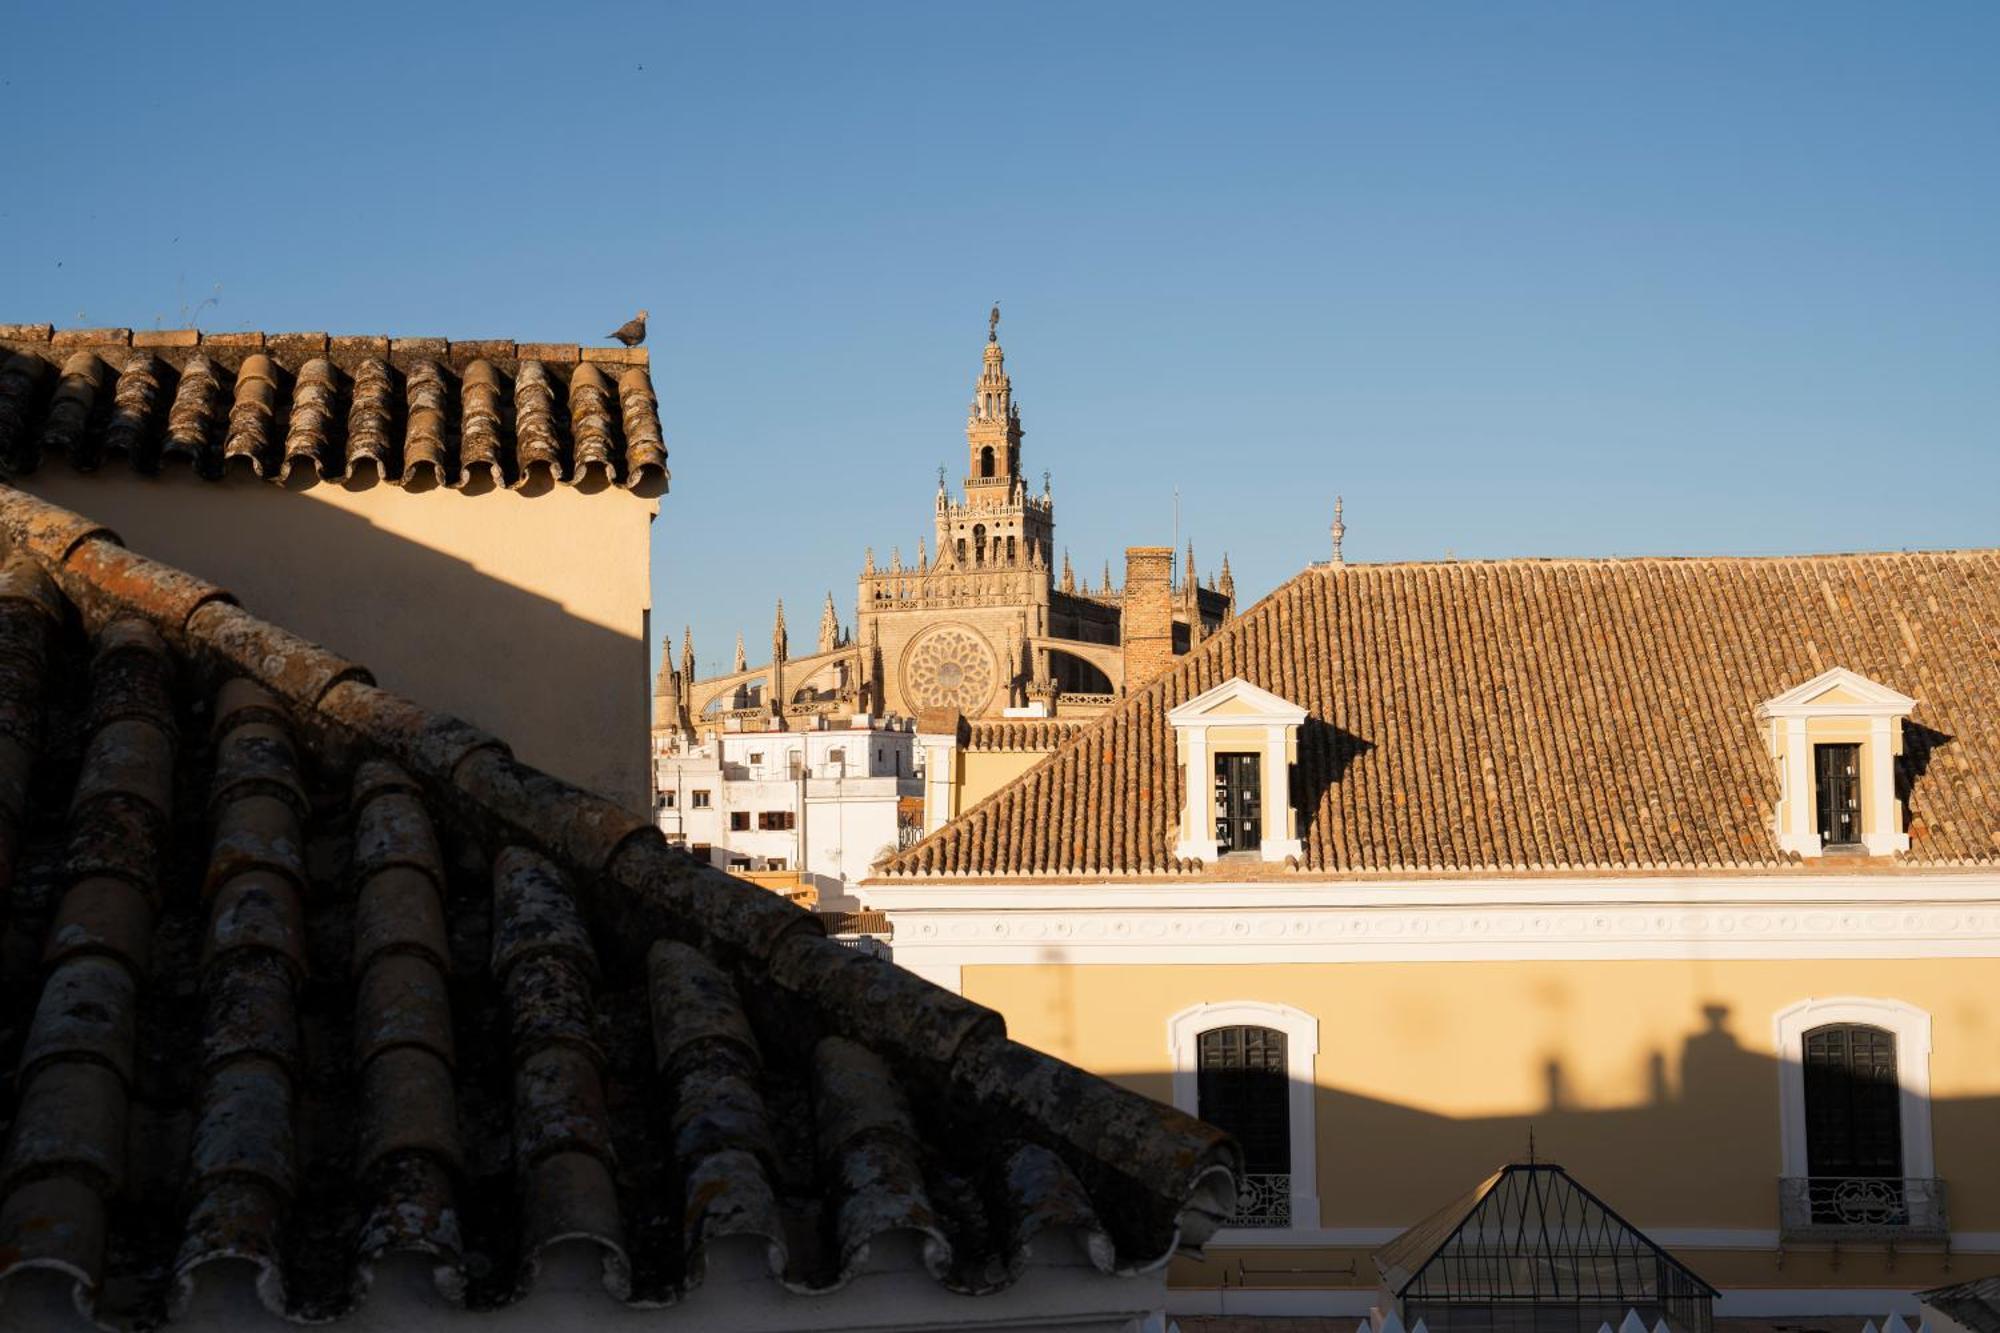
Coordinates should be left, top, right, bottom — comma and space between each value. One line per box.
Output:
16, 466, 658, 811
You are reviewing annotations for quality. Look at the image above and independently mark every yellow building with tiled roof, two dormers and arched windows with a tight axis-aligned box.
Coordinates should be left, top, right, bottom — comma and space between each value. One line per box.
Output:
862, 536, 2000, 1319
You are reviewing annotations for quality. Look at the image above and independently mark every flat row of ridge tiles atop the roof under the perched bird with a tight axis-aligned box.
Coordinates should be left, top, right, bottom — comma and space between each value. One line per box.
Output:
0, 324, 652, 366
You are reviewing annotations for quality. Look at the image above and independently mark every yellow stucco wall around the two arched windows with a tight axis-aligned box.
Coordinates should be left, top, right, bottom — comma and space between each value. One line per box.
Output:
962, 959, 2000, 1289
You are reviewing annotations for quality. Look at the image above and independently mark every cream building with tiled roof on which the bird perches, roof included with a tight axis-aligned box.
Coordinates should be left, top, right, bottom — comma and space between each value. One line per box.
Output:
0, 324, 668, 811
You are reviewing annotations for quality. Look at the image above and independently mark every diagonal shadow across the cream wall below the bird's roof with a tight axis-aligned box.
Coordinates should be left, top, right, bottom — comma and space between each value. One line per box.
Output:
16, 466, 650, 811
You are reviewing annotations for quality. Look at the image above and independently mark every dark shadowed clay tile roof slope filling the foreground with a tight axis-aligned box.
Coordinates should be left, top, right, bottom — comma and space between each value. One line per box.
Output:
0, 486, 1240, 1327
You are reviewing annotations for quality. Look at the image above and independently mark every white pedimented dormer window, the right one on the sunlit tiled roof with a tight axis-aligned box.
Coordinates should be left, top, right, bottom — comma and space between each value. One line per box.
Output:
1756, 667, 1916, 857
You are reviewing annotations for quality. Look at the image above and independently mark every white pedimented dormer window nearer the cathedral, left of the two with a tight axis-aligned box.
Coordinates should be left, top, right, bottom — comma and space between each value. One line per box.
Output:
1166, 677, 1306, 861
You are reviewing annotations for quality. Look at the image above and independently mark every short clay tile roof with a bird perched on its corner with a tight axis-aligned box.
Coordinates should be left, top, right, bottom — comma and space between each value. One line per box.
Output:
0, 324, 668, 496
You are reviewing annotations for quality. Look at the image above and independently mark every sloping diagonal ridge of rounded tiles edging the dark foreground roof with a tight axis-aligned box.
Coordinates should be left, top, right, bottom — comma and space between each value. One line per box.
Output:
0, 484, 1240, 1271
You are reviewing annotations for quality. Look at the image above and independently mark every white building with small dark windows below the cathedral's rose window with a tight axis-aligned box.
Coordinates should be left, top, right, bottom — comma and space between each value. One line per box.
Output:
654, 715, 924, 903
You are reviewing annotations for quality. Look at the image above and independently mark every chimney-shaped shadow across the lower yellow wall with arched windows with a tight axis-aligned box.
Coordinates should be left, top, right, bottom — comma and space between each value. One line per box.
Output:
1080, 1001, 2000, 1333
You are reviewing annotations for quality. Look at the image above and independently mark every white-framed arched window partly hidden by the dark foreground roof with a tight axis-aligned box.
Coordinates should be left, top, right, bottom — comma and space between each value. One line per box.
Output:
1168, 1001, 1320, 1233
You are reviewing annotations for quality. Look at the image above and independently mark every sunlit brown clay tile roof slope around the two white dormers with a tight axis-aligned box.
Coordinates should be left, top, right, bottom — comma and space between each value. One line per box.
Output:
884, 550, 2000, 879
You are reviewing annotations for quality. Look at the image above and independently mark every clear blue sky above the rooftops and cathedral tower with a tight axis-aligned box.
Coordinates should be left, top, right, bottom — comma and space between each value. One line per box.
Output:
0, 0, 2000, 673
